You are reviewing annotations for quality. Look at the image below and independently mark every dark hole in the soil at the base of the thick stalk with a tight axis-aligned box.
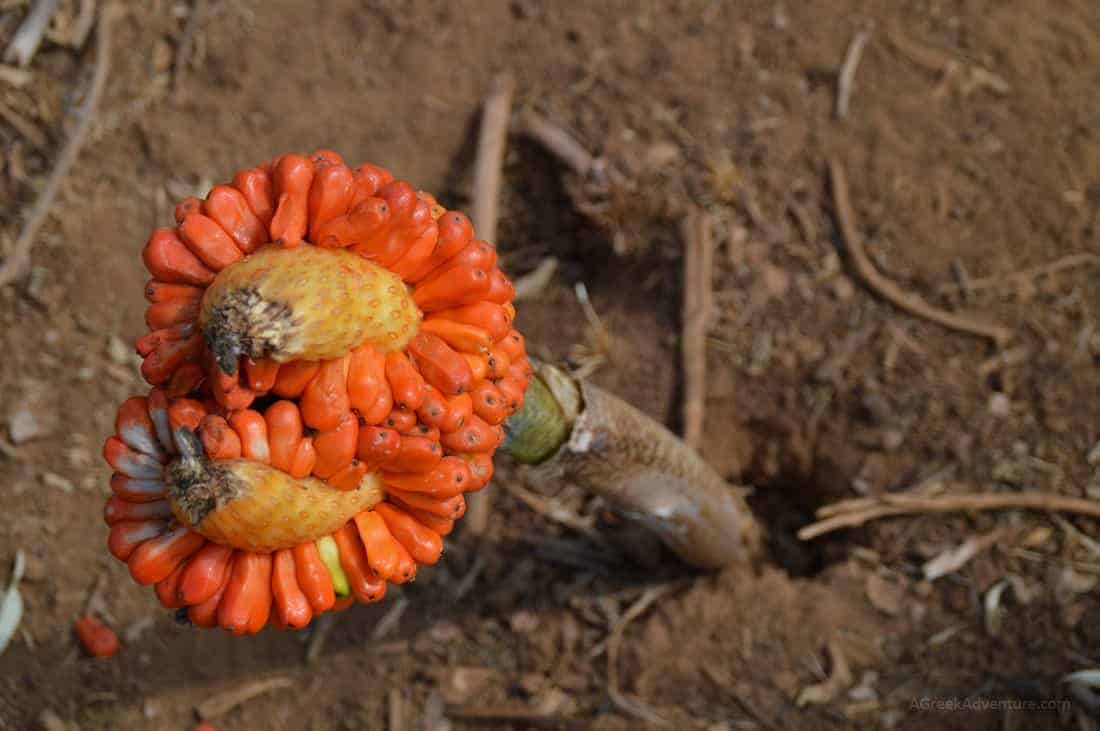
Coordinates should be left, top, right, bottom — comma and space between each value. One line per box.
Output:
745, 467, 853, 577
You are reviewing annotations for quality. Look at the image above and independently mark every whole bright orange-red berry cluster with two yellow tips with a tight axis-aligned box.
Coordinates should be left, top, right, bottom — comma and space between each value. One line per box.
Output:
103, 151, 531, 634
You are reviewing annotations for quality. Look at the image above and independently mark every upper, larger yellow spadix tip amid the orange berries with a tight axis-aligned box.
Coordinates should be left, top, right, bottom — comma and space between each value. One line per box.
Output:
199, 246, 420, 374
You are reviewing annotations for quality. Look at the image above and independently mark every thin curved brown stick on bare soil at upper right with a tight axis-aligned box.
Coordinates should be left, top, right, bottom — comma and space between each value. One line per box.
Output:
828, 157, 1012, 345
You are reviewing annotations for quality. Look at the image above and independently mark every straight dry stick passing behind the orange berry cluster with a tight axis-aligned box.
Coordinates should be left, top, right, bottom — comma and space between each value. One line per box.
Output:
465, 74, 516, 535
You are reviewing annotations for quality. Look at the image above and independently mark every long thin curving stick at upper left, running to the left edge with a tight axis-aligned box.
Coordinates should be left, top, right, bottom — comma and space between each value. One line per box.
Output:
0, 3, 114, 287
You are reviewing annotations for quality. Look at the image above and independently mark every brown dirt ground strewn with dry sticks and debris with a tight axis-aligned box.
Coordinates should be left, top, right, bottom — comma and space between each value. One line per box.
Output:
0, 0, 1100, 731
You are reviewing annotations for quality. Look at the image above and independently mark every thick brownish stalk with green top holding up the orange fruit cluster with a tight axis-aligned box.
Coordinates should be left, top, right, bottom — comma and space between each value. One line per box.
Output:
502, 364, 762, 569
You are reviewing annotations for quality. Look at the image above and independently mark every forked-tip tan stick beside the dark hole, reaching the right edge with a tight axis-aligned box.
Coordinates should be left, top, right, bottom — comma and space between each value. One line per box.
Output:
799, 492, 1100, 541
